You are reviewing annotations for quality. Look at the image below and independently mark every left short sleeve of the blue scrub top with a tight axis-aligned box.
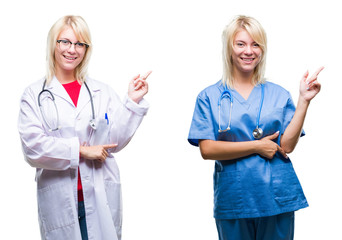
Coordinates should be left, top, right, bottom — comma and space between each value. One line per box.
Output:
188, 94, 215, 146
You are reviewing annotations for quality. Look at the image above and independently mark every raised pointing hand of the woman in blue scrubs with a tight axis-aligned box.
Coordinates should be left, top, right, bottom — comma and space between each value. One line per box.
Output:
300, 67, 324, 102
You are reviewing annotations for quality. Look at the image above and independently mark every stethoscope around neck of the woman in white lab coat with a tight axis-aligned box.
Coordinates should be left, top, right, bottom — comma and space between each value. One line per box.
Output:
38, 80, 96, 132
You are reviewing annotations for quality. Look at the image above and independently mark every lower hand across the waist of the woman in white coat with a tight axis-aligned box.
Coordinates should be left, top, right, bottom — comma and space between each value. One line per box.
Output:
80, 144, 117, 163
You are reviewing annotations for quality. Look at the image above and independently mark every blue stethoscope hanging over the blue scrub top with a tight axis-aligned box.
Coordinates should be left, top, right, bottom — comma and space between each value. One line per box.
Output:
218, 84, 264, 139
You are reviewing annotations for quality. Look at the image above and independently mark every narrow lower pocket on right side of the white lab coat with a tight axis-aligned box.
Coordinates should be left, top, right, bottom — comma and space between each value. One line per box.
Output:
105, 181, 122, 233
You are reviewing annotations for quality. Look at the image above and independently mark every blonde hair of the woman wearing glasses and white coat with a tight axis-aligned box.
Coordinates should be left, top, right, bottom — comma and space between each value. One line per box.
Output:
45, 15, 92, 84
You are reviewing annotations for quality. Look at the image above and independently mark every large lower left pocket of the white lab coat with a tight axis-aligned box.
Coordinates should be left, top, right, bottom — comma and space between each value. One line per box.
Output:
38, 184, 76, 232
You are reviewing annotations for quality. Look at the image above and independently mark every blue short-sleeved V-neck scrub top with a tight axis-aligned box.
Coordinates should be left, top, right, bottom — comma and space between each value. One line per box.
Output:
188, 81, 308, 219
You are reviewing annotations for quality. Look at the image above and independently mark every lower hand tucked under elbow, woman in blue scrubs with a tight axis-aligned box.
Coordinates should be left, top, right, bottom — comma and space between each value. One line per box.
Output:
257, 131, 288, 159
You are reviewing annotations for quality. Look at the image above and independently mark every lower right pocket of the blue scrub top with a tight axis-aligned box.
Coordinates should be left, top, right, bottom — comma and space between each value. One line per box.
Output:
272, 163, 305, 205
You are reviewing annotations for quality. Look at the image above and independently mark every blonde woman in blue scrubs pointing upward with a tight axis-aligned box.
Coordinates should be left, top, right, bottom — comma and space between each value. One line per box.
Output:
188, 16, 323, 240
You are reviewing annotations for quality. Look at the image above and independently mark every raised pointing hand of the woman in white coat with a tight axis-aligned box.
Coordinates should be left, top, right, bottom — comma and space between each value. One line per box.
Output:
128, 71, 152, 103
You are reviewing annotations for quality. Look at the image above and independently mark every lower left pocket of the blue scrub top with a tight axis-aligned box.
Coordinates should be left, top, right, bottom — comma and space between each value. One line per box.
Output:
214, 171, 243, 213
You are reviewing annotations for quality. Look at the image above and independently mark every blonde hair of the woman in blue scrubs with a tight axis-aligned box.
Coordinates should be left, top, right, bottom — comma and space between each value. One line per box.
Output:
222, 15, 267, 87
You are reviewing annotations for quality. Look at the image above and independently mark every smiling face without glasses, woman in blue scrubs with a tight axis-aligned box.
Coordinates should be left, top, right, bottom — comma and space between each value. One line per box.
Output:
232, 29, 262, 75
